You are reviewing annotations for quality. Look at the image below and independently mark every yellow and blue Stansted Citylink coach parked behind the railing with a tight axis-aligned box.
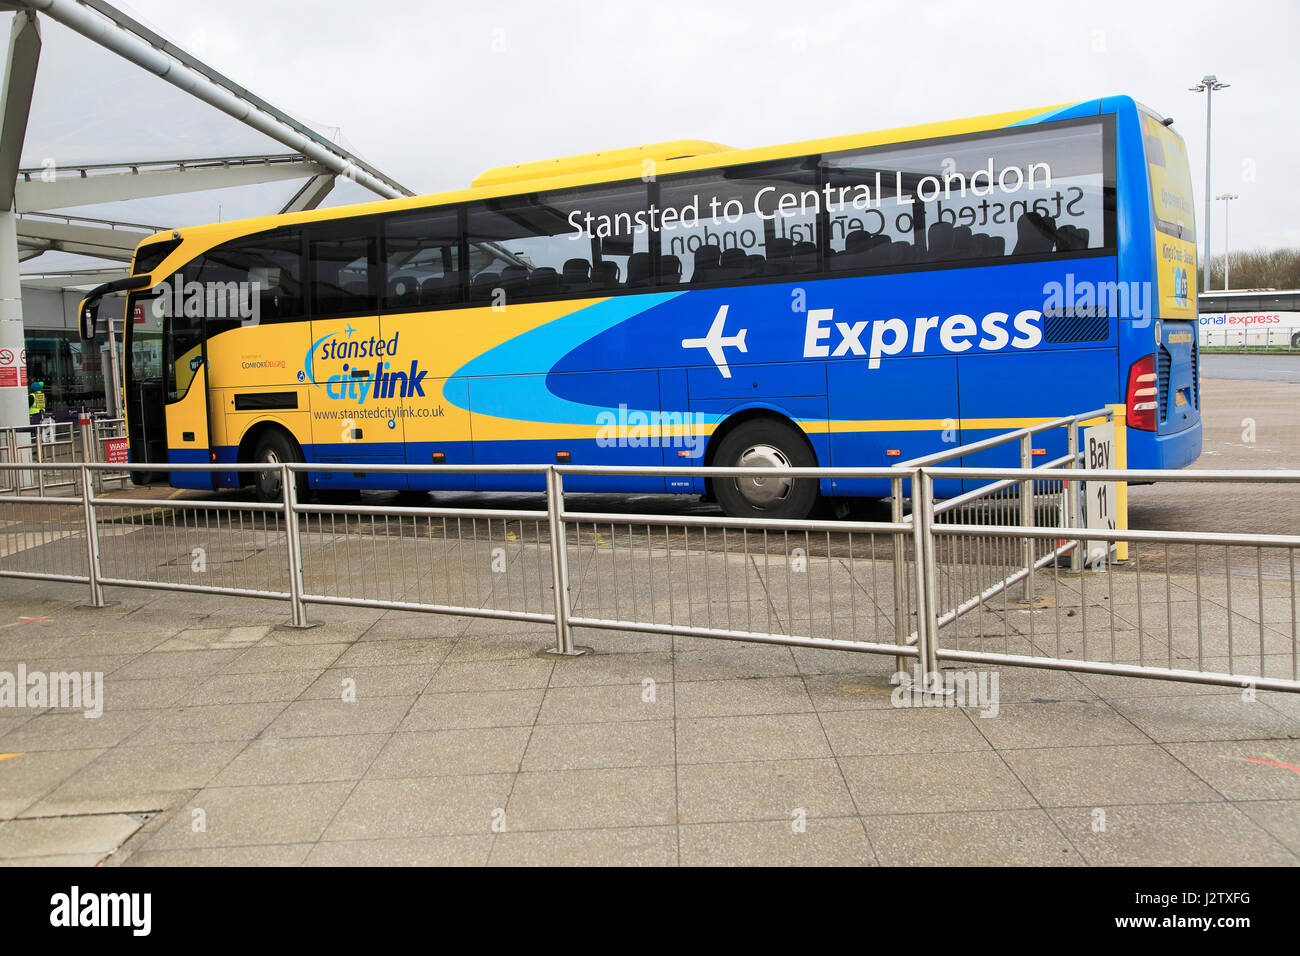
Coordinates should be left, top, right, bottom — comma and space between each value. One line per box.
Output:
83, 96, 1201, 518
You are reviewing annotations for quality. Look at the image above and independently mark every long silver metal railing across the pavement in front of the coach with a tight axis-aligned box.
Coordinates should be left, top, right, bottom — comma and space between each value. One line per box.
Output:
0, 455, 1300, 691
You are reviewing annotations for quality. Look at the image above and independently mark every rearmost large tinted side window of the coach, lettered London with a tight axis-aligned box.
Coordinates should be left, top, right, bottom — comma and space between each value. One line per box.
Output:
824, 124, 1108, 269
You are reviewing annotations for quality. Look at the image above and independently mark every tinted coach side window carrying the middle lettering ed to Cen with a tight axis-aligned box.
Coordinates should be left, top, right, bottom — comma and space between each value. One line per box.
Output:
659, 159, 820, 285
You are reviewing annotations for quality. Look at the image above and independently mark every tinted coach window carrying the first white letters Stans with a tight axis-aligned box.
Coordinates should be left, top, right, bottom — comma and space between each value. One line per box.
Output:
468, 182, 650, 302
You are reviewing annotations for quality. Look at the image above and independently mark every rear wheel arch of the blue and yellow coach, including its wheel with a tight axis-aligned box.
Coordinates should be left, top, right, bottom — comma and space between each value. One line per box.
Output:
705, 408, 820, 518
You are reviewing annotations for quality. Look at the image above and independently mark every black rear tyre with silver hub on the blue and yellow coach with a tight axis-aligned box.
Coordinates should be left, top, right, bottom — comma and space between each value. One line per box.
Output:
714, 419, 818, 519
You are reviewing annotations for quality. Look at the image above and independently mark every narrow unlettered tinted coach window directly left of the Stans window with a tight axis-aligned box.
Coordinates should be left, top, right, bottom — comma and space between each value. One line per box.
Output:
384, 209, 462, 311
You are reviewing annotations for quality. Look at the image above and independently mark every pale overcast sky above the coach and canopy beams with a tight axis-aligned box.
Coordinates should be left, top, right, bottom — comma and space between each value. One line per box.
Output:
4, 0, 1300, 271
